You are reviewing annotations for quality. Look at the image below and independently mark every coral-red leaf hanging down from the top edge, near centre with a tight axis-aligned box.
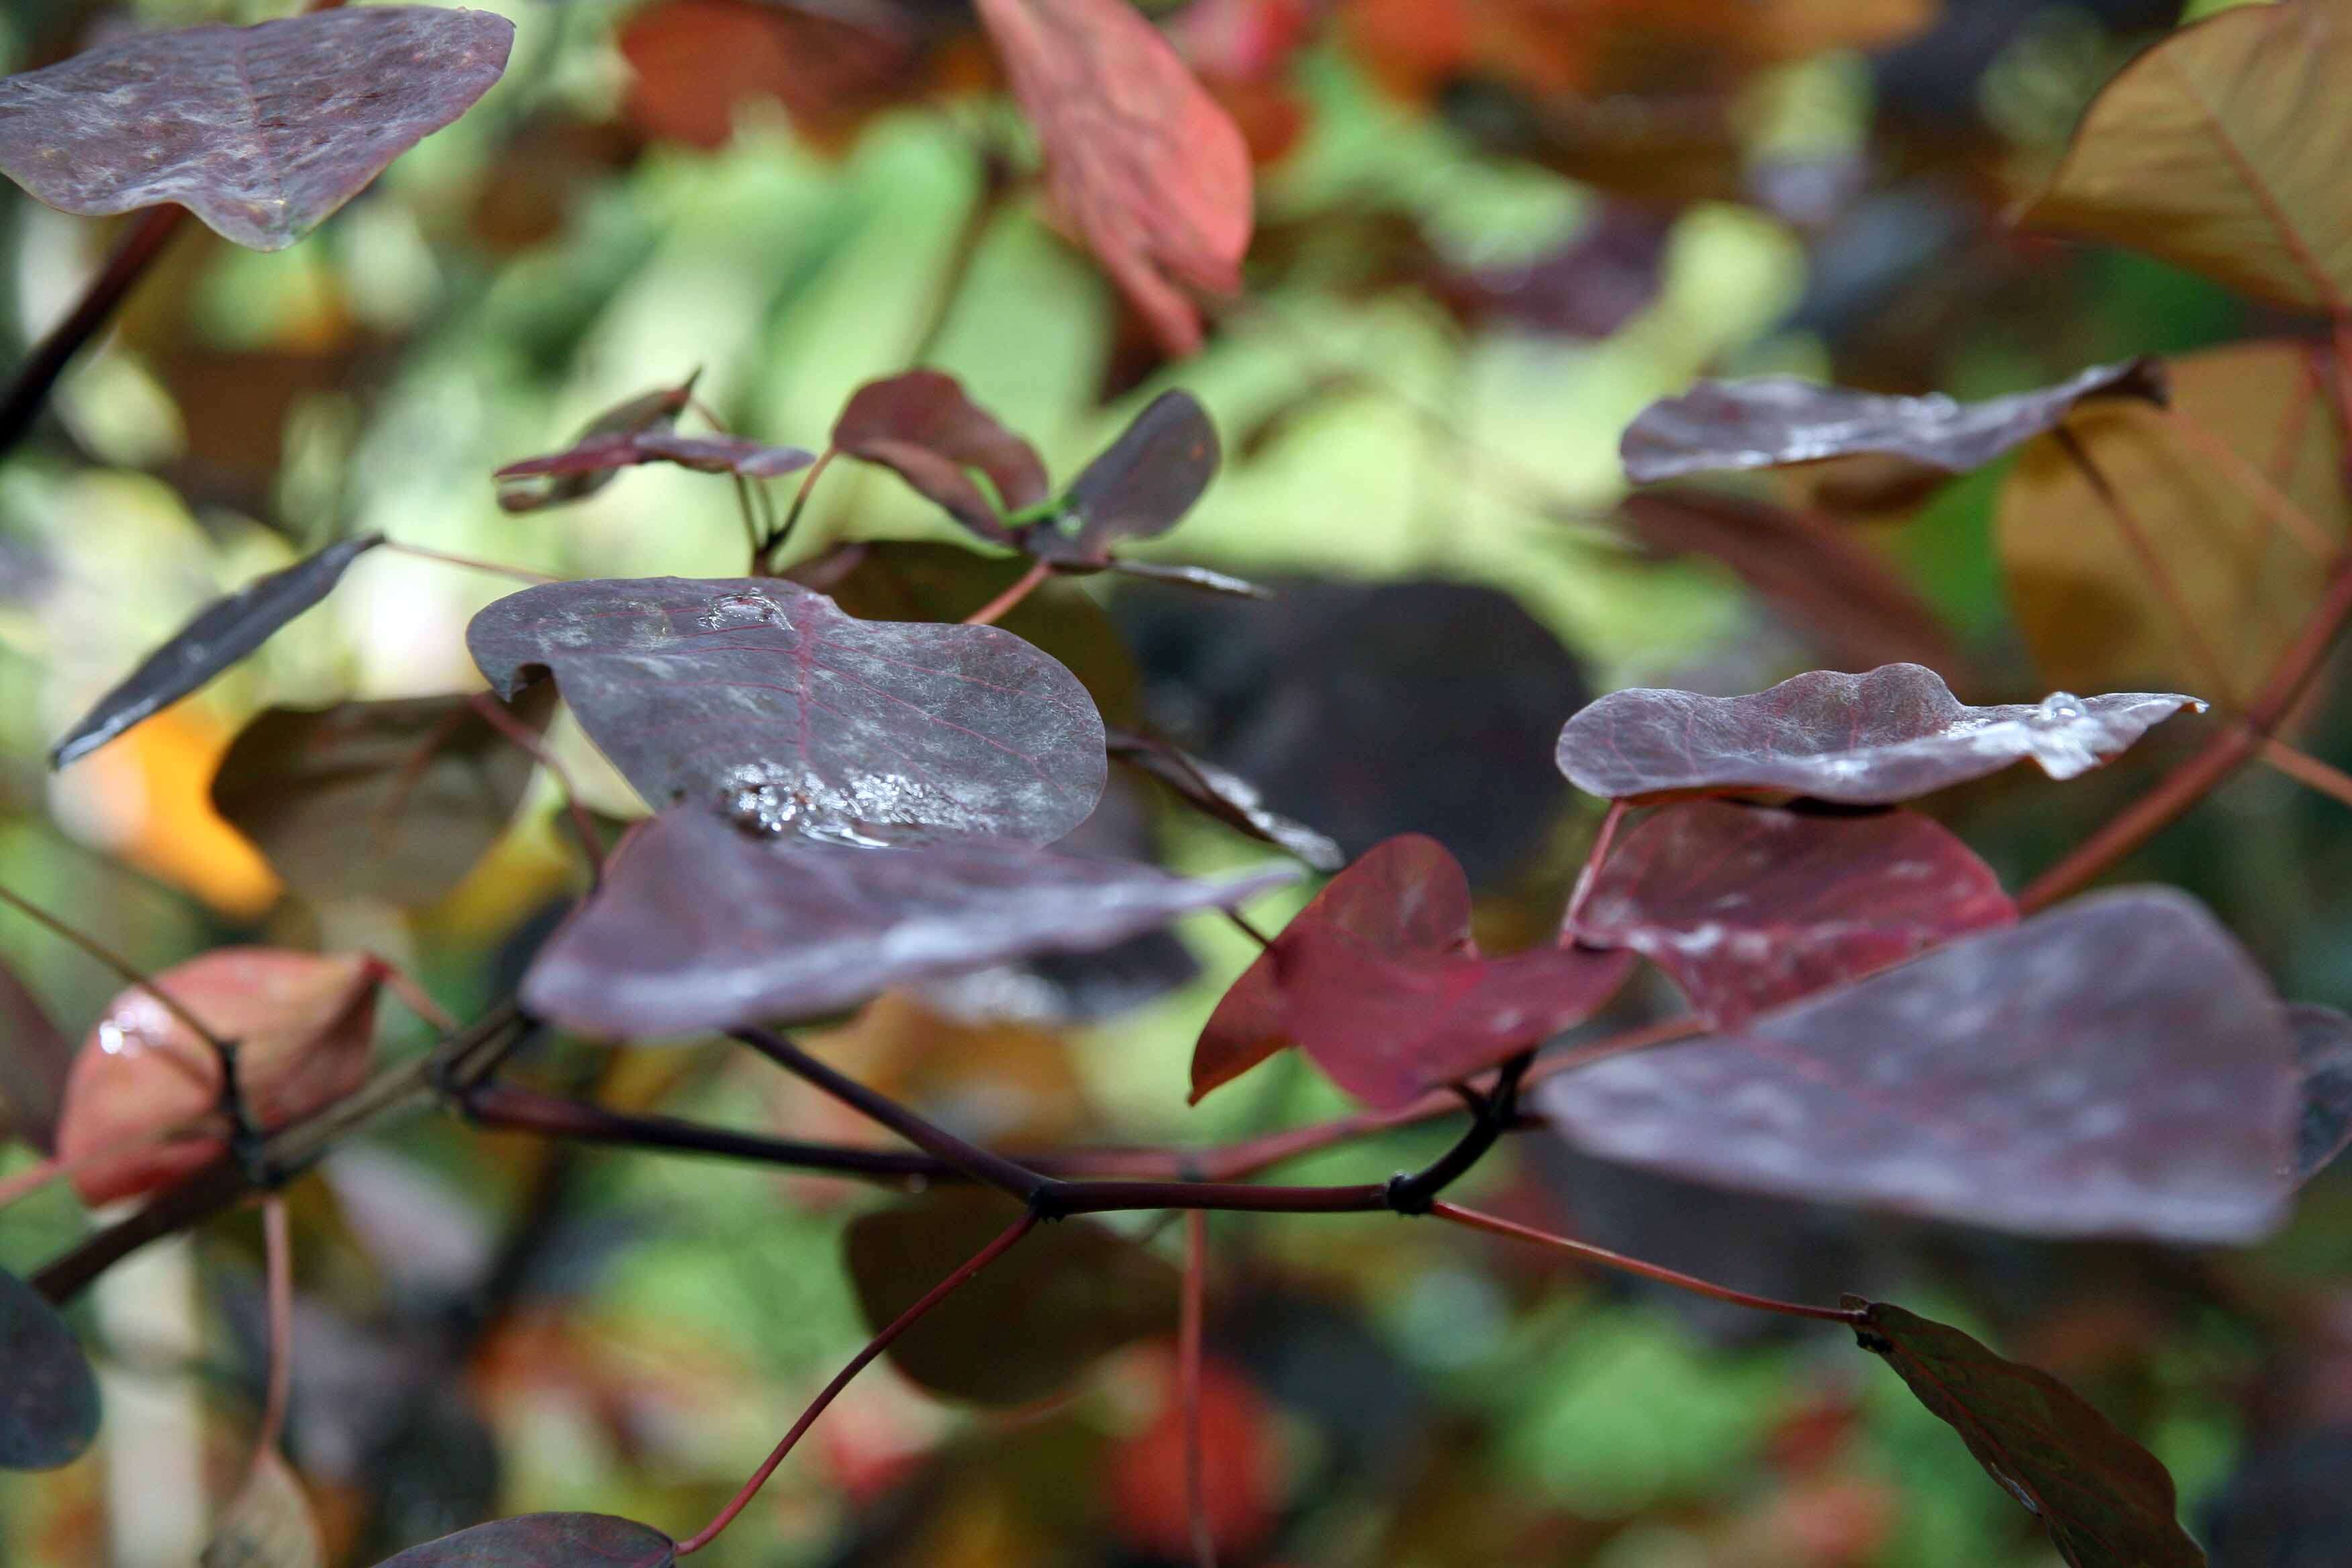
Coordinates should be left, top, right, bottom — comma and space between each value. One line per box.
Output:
979, 0, 1251, 355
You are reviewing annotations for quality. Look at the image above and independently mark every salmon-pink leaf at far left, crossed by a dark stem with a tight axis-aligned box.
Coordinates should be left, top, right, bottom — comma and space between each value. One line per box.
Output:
56, 947, 383, 1206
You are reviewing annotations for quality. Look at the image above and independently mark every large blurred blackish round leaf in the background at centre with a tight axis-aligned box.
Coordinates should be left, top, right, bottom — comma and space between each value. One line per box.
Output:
1110, 583, 1585, 886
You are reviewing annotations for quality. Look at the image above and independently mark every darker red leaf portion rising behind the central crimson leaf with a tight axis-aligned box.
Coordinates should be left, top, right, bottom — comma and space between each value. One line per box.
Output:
1193, 832, 1470, 1103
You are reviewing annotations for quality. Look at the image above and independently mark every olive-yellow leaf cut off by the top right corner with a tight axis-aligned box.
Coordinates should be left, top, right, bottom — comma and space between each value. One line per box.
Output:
2022, 0, 2352, 320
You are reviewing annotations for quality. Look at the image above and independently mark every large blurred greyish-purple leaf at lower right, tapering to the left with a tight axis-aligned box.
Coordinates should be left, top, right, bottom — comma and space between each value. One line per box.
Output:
1540, 889, 2302, 1241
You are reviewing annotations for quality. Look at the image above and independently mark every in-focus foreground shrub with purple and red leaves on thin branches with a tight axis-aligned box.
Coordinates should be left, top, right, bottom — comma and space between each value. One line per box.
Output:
0, 0, 2352, 1568
